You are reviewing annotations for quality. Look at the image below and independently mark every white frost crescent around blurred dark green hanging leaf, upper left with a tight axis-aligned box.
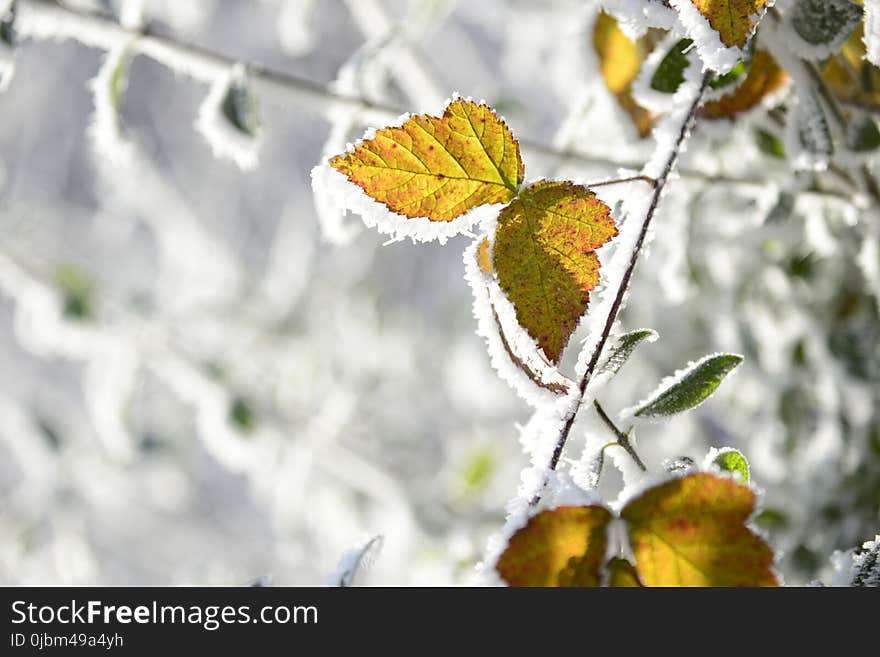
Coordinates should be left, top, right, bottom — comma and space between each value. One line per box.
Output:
195, 64, 262, 171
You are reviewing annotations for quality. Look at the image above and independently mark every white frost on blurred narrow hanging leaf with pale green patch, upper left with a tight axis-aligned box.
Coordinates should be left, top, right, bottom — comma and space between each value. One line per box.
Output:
89, 43, 134, 164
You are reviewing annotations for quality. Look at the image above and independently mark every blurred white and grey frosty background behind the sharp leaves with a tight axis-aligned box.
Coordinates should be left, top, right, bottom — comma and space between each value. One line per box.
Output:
0, 0, 880, 585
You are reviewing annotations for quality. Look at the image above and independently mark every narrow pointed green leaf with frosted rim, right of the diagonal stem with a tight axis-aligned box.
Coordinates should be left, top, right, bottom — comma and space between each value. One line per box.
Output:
632, 354, 743, 418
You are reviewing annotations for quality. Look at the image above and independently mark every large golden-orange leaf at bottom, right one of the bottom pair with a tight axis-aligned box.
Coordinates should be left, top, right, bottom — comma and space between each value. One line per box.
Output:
620, 473, 778, 586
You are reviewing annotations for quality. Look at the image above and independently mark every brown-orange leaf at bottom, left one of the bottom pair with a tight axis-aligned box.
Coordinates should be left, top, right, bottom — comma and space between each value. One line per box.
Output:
495, 506, 611, 586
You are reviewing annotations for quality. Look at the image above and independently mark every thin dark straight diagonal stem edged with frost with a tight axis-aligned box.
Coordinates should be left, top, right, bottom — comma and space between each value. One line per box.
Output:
531, 73, 711, 506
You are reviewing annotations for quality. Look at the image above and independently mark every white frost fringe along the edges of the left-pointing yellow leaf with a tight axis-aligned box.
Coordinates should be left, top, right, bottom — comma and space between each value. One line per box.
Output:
311, 94, 505, 249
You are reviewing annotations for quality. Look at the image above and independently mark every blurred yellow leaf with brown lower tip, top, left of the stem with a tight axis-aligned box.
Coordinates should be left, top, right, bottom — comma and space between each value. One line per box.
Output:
593, 12, 654, 137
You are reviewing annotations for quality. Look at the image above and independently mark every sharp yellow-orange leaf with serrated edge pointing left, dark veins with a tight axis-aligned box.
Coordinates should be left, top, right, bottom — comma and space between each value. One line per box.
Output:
330, 99, 524, 221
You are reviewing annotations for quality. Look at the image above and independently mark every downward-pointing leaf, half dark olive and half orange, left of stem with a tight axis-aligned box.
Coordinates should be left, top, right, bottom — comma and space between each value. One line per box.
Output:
492, 181, 617, 363
